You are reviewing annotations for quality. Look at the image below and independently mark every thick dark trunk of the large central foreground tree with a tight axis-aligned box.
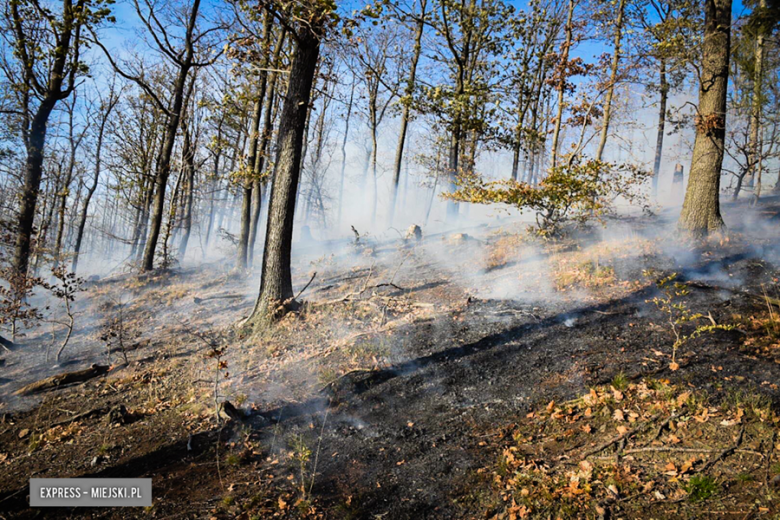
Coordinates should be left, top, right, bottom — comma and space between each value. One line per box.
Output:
248, 29, 320, 326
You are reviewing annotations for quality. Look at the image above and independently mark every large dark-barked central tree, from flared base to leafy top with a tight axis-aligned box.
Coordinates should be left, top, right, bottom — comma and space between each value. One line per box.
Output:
247, 0, 338, 327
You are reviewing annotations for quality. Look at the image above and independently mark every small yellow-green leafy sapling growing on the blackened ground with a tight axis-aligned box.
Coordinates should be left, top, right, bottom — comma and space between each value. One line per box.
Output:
648, 273, 736, 371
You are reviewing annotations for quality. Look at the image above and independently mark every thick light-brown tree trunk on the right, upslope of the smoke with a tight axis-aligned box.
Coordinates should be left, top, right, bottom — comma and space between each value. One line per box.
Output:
678, 0, 731, 237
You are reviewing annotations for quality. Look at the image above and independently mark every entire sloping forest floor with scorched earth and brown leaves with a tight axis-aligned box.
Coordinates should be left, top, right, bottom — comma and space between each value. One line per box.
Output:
0, 200, 780, 520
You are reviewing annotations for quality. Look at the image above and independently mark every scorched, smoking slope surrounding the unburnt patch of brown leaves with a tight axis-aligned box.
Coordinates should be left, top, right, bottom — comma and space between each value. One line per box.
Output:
0, 200, 780, 519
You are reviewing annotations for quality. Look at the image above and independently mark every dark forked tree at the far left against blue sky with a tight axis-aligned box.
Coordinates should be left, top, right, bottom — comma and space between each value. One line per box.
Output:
2, 0, 111, 275
